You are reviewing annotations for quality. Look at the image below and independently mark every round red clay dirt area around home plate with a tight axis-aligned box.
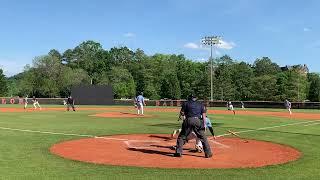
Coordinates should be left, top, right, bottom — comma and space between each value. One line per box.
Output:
50, 134, 301, 169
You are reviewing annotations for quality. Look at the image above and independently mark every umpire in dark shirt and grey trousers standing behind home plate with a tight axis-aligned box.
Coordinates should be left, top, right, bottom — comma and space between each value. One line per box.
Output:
174, 94, 212, 158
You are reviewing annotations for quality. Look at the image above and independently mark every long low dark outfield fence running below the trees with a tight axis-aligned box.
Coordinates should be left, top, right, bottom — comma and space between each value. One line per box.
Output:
0, 97, 320, 109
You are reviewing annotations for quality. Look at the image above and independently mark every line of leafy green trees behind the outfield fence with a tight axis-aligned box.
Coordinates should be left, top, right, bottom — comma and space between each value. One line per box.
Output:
0, 41, 320, 101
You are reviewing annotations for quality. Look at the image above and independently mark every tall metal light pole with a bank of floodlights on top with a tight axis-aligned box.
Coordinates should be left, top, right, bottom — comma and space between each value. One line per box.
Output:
201, 36, 221, 101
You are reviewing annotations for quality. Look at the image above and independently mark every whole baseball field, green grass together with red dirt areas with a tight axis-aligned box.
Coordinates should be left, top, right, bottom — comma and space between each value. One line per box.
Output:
0, 105, 320, 179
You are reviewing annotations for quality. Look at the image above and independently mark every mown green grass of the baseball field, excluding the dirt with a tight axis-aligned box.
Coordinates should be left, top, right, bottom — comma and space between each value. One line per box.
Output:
0, 105, 320, 180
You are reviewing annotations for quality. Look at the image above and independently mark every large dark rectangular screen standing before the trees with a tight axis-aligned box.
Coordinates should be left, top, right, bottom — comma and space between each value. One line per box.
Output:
71, 85, 114, 105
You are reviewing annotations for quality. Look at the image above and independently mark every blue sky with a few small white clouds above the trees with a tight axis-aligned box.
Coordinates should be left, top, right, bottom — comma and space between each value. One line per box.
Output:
0, 0, 320, 77
